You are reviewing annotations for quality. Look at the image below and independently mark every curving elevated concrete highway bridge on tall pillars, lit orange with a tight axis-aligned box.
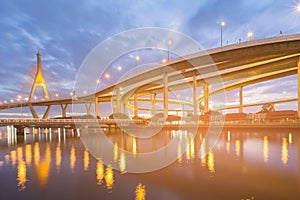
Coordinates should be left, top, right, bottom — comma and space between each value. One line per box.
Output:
0, 34, 300, 118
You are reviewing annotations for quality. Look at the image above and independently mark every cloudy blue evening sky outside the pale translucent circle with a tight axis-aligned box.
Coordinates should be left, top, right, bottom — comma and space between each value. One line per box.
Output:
0, 0, 300, 115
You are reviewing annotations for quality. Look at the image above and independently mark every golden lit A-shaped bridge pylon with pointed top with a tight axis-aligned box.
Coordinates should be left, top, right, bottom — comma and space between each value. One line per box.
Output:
29, 50, 50, 101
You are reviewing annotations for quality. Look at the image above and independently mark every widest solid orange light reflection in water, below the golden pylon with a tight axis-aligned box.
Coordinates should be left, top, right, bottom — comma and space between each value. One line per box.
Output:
37, 144, 51, 186
